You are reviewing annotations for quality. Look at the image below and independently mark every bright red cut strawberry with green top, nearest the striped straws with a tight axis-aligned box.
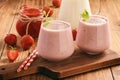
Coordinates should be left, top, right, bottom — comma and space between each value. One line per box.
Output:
7, 47, 18, 61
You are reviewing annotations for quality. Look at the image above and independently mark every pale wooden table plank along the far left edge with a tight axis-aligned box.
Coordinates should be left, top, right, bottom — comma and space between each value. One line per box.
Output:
0, 0, 17, 57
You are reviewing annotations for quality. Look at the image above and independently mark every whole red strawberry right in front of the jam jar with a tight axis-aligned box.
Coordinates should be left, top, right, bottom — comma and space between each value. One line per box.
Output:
20, 35, 34, 50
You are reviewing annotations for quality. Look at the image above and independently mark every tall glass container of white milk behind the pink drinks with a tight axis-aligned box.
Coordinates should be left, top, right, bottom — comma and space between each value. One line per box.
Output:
58, 0, 91, 28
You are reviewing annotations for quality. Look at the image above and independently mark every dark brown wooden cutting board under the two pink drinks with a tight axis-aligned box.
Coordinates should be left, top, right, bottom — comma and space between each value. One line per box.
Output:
0, 50, 120, 80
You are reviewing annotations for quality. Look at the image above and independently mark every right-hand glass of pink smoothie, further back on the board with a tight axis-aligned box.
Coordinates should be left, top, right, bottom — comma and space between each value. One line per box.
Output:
76, 15, 111, 55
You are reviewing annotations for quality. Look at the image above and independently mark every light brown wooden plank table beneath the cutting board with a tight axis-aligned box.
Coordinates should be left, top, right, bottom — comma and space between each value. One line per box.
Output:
0, 0, 120, 80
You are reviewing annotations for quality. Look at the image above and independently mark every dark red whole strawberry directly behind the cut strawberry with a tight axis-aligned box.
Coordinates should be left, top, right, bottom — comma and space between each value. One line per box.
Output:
4, 34, 17, 46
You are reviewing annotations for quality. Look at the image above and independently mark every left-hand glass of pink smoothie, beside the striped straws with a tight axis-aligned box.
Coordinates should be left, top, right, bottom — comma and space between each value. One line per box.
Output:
37, 20, 74, 61
